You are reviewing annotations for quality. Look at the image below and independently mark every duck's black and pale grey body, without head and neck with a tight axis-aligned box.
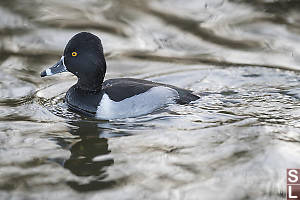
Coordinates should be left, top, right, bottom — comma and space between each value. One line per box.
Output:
66, 78, 199, 119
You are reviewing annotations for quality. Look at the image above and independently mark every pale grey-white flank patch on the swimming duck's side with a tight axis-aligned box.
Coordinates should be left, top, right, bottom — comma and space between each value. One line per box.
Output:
96, 86, 179, 119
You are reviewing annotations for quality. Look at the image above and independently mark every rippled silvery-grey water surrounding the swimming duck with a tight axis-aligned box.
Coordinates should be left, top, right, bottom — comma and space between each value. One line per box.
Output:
0, 0, 300, 200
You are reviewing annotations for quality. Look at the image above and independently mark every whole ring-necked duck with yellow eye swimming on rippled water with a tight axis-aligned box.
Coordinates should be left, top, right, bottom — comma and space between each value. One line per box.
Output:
41, 32, 199, 119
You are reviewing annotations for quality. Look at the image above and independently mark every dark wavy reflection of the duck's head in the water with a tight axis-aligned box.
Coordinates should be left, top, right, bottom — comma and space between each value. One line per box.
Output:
64, 121, 116, 192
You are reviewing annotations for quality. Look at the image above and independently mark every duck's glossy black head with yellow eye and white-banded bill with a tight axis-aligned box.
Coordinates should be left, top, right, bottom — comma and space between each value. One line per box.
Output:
41, 32, 106, 91
